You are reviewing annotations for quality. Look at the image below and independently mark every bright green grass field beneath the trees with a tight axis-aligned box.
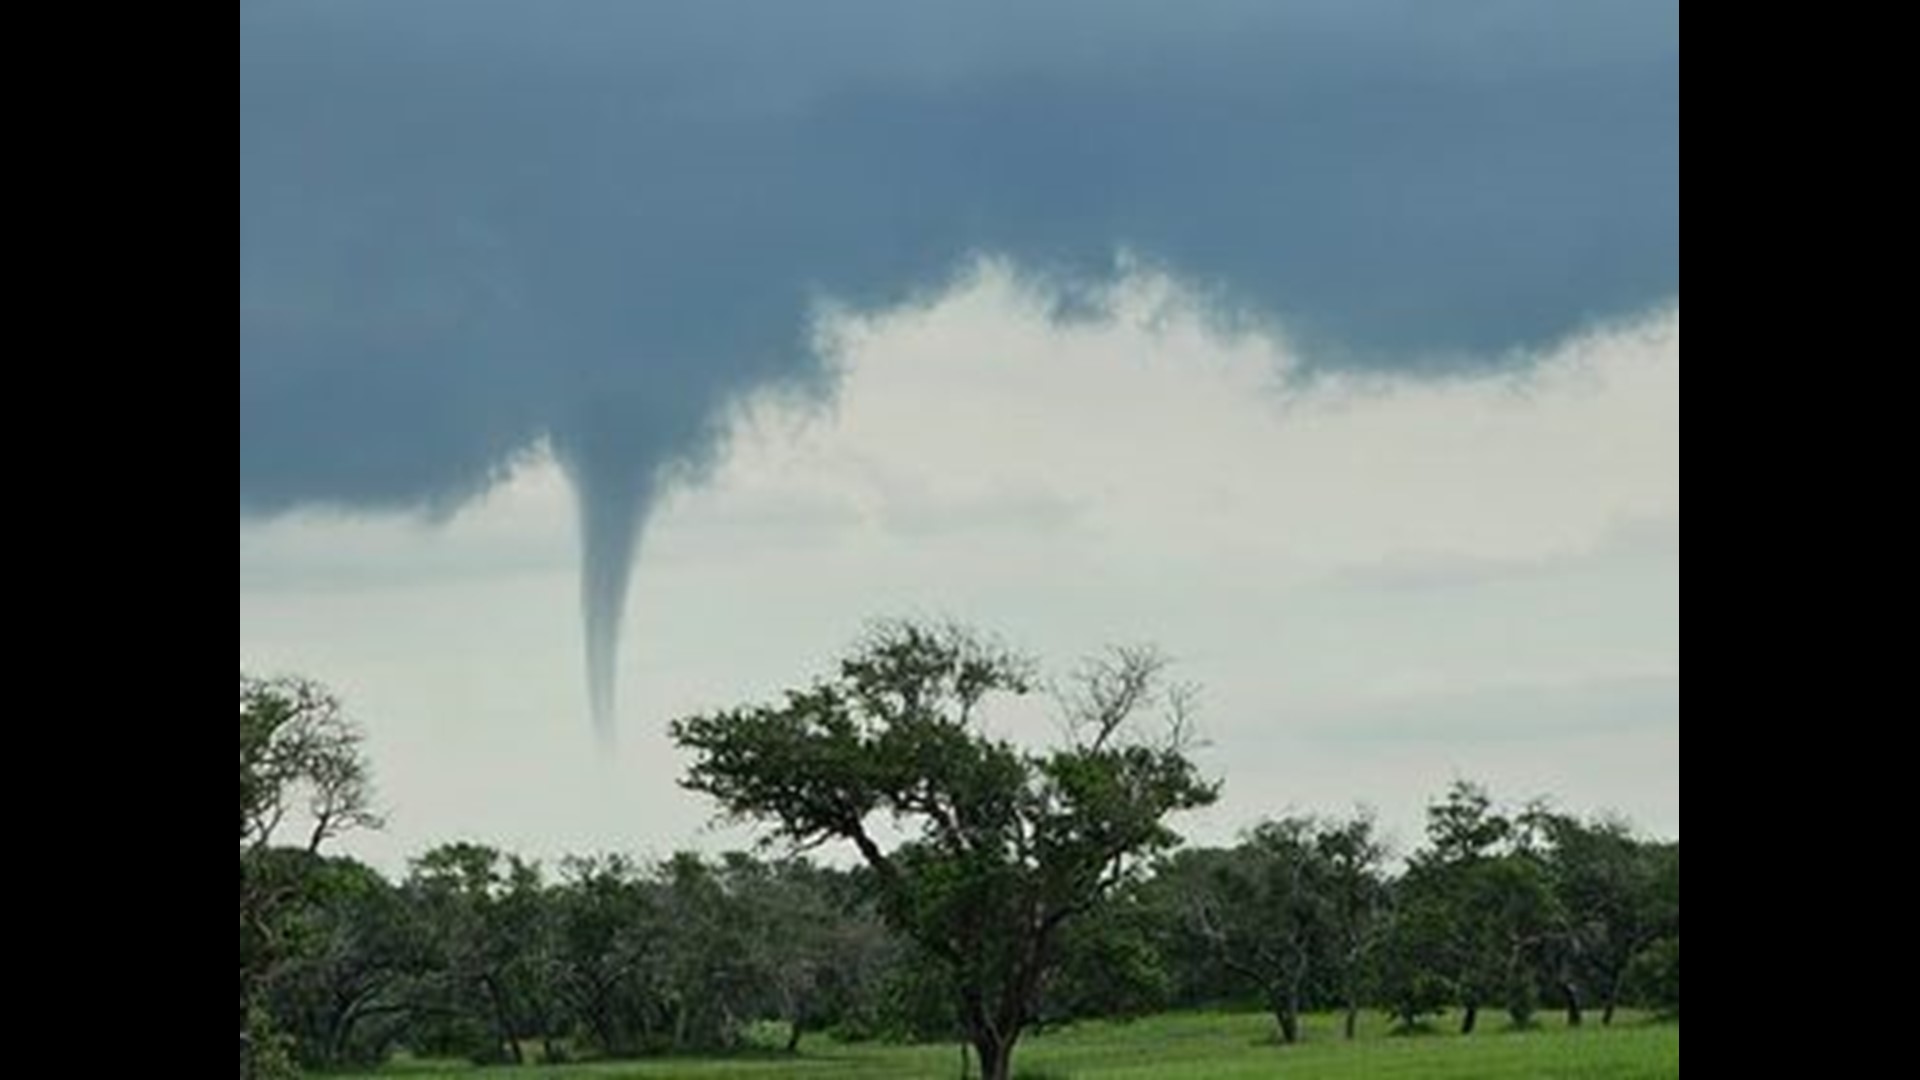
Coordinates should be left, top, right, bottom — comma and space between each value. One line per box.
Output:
341, 1013, 1680, 1080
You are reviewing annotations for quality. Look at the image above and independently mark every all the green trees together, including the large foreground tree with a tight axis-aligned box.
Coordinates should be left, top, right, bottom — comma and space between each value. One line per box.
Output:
240, 653, 1680, 1076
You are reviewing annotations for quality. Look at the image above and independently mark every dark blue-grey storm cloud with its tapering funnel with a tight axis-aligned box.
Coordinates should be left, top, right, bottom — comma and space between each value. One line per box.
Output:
240, 0, 1680, 736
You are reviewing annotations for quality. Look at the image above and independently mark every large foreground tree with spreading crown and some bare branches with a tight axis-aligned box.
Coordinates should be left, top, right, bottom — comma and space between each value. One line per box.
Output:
672, 623, 1217, 1080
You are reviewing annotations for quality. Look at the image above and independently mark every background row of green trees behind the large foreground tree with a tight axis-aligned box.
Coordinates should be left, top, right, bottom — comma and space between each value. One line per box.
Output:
242, 780, 1680, 1068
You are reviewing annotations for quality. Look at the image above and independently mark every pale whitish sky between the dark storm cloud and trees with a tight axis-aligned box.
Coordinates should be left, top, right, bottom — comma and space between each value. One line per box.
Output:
240, 265, 1678, 865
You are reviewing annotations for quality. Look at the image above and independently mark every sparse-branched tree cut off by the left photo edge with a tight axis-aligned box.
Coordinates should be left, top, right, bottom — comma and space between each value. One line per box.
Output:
240, 671, 380, 1074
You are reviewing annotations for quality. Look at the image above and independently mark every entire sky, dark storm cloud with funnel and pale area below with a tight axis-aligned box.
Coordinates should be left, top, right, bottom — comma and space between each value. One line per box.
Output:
240, 0, 1680, 869
